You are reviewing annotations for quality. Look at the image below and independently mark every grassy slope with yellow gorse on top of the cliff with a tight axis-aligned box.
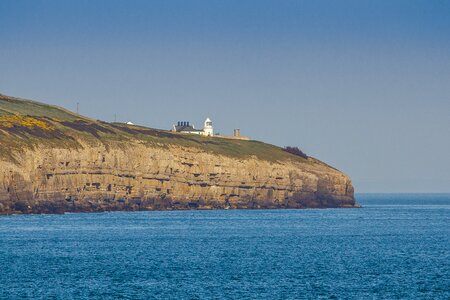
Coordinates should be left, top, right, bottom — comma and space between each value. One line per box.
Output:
0, 94, 317, 163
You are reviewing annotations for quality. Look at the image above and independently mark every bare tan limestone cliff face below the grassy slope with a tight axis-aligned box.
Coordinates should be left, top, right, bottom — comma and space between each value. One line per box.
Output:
0, 141, 355, 214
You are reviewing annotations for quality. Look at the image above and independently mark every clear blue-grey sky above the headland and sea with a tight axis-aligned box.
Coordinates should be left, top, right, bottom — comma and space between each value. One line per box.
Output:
0, 0, 450, 192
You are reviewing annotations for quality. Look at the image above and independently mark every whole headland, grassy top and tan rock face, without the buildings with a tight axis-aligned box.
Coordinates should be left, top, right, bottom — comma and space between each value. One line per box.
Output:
0, 95, 355, 214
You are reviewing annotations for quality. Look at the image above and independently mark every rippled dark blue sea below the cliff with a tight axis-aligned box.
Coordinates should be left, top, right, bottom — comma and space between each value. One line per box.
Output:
0, 195, 450, 299
